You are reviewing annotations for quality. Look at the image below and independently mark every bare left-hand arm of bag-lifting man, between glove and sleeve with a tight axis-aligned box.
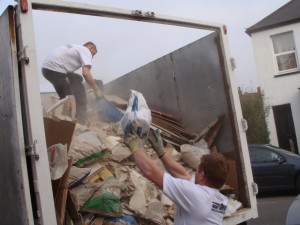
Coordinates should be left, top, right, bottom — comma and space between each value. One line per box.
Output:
132, 150, 164, 189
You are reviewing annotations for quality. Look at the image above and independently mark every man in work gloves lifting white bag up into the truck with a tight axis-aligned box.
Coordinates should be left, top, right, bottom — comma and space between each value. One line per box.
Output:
126, 130, 229, 225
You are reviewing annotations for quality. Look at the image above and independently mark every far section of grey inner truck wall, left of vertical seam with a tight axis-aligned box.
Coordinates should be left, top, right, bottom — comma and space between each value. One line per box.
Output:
105, 55, 180, 117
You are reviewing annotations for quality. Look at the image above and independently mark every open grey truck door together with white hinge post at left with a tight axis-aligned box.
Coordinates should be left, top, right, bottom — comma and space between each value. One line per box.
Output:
0, 5, 56, 225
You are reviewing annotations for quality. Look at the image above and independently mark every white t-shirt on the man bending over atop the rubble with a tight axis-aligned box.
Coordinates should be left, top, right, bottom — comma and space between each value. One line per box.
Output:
42, 44, 93, 73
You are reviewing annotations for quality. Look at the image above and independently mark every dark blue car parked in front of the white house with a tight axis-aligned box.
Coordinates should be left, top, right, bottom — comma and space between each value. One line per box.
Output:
248, 144, 300, 193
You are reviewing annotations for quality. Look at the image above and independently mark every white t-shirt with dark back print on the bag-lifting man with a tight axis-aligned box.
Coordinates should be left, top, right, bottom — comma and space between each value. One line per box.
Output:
163, 173, 228, 225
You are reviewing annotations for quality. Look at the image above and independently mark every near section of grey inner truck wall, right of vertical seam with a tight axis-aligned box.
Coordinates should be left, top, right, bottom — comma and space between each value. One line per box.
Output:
172, 33, 236, 152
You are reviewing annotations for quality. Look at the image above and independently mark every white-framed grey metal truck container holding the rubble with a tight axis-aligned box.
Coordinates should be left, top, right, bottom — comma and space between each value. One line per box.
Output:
0, 0, 258, 225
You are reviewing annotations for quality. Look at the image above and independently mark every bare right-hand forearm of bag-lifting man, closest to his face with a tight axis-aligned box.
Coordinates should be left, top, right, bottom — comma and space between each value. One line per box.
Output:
160, 150, 192, 180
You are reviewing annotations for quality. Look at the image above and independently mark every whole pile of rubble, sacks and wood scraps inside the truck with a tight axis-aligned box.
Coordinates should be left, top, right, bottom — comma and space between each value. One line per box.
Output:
44, 94, 241, 225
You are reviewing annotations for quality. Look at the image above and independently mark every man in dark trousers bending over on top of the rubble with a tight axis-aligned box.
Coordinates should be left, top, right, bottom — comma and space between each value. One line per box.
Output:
42, 42, 102, 124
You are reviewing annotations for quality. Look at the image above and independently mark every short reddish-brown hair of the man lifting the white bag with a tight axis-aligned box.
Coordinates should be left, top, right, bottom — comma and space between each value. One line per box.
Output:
199, 152, 229, 189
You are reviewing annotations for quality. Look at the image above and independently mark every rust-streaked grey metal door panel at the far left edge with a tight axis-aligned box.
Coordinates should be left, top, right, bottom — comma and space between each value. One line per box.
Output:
0, 8, 29, 225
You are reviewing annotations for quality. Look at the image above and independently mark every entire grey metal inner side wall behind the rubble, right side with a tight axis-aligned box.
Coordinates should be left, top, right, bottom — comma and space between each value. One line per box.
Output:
105, 32, 234, 152
